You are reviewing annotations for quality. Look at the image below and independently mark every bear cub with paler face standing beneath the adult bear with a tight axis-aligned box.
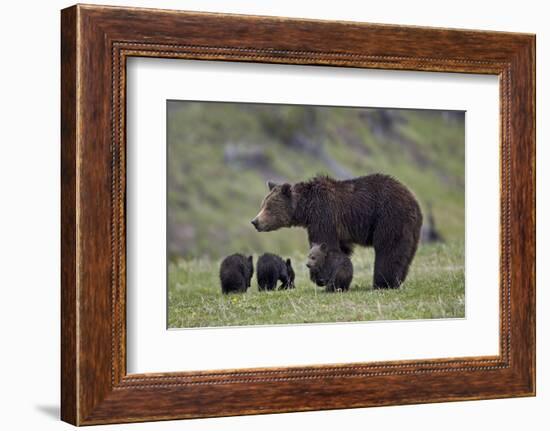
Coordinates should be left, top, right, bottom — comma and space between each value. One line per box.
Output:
306, 243, 353, 292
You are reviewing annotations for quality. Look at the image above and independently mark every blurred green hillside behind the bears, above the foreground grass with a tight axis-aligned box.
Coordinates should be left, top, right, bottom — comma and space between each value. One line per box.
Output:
167, 101, 465, 261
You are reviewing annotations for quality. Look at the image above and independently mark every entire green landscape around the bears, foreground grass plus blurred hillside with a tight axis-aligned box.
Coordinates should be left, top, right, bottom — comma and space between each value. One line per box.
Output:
167, 101, 465, 328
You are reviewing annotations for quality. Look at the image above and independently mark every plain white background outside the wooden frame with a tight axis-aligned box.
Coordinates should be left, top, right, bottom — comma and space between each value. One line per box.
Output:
0, 0, 550, 431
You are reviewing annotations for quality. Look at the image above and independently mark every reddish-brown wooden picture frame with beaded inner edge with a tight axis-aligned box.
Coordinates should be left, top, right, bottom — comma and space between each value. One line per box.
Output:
61, 5, 535, 425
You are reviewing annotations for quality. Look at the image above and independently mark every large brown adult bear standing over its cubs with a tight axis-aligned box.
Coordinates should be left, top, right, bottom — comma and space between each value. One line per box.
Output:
252, 174, 422, 288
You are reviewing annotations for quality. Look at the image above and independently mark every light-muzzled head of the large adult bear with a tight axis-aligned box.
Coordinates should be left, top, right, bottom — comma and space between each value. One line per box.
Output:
251, 181, 297, 232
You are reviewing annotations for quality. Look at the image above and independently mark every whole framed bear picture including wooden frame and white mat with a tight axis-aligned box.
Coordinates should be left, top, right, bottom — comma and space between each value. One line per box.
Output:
61, 5, 535, 425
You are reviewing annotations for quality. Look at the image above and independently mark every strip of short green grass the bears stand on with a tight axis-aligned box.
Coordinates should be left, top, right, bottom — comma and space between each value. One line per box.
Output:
168, 242, 464, 328
